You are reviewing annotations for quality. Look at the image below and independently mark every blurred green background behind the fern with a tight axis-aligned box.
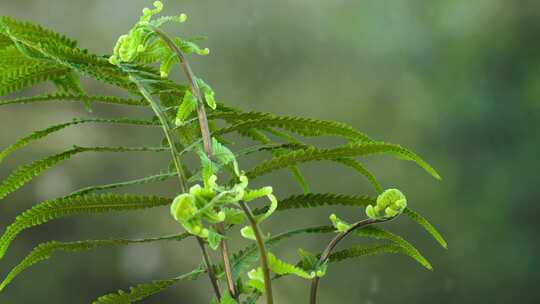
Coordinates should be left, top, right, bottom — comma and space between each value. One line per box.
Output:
0, 0, 540, 304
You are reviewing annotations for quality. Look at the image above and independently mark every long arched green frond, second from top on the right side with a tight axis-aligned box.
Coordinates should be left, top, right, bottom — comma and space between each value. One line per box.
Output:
246, 142, 440, 179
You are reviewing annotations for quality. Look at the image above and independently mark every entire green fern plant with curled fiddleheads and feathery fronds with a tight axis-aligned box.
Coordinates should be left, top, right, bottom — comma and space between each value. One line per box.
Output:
0, 1, 447, 304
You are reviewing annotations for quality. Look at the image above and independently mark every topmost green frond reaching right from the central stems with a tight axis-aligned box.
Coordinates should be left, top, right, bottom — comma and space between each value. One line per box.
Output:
212, 112, 373, 142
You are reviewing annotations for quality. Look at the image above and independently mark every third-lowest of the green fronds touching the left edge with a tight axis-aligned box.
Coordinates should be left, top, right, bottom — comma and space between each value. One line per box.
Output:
0, 147, 167, 199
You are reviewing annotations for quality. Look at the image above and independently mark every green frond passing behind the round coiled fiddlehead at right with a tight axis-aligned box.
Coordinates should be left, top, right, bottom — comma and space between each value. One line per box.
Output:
274, 193, 448, 249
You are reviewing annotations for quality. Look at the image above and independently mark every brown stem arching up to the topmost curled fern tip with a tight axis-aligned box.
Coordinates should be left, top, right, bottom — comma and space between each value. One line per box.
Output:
152, 27, 237, 298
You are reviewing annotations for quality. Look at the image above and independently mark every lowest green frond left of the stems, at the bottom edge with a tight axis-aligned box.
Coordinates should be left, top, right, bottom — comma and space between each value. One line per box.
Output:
92, 270, 204, 304
